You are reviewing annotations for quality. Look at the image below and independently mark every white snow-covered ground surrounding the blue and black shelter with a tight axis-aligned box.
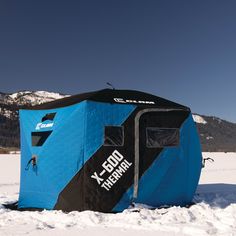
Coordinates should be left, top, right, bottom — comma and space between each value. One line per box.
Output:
0, 153, 236, 236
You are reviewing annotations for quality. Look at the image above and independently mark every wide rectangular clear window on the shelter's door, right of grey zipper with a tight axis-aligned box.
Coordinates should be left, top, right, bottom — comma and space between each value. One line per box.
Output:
146, 127, 179, 148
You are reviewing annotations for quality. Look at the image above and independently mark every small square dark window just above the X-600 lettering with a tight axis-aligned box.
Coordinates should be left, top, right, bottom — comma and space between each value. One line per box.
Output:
104, 126, 124, 146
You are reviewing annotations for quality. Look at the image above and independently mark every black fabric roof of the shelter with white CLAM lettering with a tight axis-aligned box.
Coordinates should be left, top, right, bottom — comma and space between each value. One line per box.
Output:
27, 89, 190, 110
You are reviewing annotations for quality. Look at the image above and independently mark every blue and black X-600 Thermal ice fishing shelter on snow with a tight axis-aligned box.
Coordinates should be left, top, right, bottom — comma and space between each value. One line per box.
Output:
18, 89, 202, 212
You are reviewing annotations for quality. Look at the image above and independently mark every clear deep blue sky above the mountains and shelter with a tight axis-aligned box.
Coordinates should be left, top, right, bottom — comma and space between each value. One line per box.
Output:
0, 0, 236, 122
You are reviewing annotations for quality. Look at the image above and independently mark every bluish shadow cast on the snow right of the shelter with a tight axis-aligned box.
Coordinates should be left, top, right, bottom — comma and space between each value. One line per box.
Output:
195, 183, 236, 209
